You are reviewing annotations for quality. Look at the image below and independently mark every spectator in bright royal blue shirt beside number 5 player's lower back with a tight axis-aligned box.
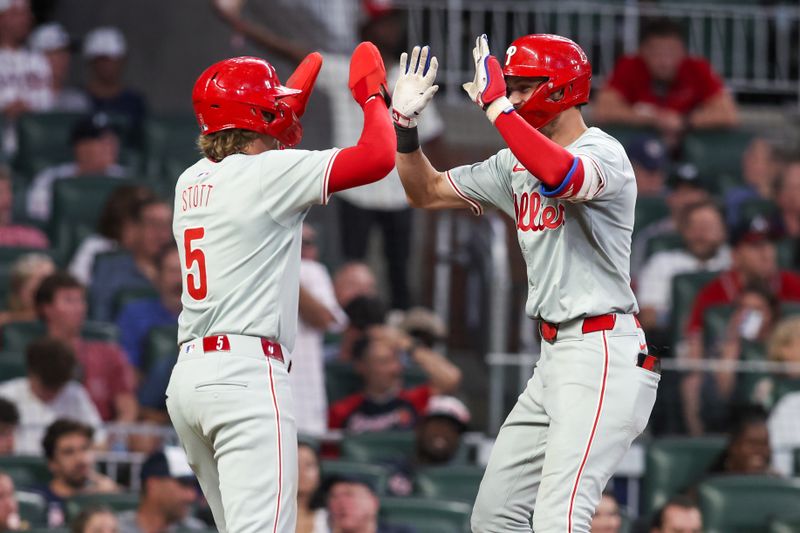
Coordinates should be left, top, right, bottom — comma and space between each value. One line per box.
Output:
117, 243, 181, 371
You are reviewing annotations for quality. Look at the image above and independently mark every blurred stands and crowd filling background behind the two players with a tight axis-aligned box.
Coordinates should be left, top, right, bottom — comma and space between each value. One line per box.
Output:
0, 0, 800, 533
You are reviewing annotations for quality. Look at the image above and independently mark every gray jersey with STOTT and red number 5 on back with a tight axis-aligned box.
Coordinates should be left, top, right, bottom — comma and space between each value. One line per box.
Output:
173, 149, 338, 350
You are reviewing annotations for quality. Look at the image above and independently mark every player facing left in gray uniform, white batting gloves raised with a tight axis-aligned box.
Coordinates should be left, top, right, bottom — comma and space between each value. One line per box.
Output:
393, 35, 660, 533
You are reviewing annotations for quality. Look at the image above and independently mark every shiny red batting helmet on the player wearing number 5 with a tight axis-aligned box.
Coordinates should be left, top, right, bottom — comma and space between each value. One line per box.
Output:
192, 57, 303, 146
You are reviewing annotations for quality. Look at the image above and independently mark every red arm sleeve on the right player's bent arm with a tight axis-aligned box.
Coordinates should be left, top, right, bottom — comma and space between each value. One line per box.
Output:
494, 111, 583, 191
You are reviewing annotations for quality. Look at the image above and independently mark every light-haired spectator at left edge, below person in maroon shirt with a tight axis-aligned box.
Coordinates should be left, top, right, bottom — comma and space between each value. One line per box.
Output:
0, 253, 56, 326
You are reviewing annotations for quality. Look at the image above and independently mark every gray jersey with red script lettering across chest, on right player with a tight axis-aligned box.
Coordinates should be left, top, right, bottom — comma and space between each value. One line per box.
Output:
446, 128, 639, 323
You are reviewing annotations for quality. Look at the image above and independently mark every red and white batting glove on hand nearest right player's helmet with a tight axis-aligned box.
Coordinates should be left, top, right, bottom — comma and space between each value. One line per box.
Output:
462, 33, 514, 123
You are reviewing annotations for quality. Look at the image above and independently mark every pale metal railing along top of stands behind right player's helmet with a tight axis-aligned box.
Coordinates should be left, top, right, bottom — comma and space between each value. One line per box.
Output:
395, 0, 800, 104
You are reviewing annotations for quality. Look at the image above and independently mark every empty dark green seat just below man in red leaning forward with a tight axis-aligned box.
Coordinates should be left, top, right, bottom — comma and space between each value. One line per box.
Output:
683, 129, 753, 184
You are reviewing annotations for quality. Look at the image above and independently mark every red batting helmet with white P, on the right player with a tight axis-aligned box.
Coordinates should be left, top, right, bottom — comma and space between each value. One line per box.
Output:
503, 34, 592, 128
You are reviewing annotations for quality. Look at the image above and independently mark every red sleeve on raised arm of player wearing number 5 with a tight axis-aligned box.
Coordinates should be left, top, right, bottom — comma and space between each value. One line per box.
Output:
328, 97, 397, 194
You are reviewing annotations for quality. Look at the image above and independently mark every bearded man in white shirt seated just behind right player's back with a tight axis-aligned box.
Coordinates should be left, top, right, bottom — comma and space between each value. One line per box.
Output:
636, 200, 731, 333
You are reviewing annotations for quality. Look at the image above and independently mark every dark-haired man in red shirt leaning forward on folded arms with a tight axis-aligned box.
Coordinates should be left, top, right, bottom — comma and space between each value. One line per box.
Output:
594, 19, 739, 145
